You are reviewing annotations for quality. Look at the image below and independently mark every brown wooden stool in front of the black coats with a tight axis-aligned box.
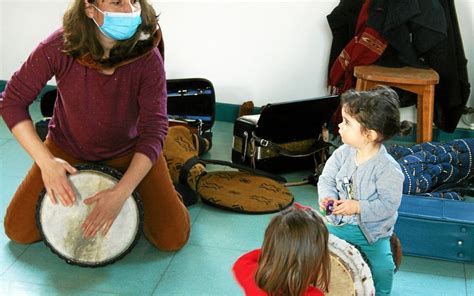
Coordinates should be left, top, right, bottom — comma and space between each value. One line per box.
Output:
354, 65, 439, 143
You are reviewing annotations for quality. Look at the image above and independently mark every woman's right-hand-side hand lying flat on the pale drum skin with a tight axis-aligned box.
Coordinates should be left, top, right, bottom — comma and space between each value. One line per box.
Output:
82, 187, 129, 238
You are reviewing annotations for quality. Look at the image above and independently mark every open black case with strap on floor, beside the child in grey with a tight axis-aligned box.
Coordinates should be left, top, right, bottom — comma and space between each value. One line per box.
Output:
232, 96, 339, 172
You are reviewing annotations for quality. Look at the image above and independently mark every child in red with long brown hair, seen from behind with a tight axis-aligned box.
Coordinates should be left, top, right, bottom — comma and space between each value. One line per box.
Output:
233, 207, 330, 296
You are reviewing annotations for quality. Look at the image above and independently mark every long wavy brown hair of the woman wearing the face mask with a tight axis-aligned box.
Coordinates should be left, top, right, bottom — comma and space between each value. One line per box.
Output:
63, 0, 158, 68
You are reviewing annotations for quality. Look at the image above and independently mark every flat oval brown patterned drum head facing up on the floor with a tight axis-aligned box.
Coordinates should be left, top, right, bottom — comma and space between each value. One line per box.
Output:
197, 171, 293, 214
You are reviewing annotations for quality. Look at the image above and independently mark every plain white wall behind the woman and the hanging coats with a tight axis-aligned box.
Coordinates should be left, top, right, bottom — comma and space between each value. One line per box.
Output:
0, 0, 474, 125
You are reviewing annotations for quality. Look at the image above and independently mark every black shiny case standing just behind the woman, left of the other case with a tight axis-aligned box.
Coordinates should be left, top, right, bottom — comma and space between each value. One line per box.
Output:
166, 78, 216, 140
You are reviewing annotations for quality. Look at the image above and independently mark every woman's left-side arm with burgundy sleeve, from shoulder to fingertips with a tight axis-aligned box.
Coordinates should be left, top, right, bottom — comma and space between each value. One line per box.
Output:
0, 30, 76, 205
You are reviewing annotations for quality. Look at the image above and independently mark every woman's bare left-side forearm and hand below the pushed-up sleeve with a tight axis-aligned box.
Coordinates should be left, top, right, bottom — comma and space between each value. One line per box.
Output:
12, 120, 76, 206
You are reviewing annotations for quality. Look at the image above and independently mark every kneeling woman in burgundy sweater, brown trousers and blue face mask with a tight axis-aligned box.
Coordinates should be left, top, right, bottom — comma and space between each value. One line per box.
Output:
0, 0, 190, 251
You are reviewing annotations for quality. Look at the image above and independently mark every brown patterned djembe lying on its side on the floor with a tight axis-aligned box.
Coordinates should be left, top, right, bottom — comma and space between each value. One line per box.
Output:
163, 126, 293, 213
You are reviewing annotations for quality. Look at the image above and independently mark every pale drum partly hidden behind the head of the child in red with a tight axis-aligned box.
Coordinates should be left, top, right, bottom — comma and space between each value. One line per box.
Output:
325, 234, 375, 296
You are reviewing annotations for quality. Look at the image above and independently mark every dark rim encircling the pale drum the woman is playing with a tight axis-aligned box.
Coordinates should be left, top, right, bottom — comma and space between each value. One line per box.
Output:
35, 163, 144, 268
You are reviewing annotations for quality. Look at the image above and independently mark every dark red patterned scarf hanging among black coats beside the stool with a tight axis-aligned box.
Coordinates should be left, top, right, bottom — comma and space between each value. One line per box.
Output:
328, 0, 388, 94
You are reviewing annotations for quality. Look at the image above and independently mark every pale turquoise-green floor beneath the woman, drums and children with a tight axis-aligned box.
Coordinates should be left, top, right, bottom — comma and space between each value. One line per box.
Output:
0, 103, 474, 296
